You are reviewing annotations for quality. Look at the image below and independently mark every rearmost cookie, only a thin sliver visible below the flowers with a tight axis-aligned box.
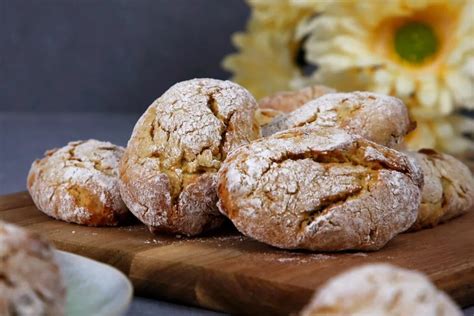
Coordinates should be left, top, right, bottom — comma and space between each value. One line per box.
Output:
258, 85, 336, 113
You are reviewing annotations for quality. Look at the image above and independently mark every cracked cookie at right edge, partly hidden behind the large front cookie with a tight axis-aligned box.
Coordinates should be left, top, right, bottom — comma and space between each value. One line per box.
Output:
407, 149, 474, 231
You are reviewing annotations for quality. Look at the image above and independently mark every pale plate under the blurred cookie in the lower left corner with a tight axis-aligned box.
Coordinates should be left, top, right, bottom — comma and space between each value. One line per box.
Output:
55, 250, 133, 316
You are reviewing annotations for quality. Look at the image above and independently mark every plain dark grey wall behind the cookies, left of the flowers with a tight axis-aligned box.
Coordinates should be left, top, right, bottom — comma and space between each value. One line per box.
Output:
0, 0, 249, 112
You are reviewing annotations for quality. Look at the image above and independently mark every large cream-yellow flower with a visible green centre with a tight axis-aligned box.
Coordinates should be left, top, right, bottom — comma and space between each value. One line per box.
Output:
298, 0, 474, 116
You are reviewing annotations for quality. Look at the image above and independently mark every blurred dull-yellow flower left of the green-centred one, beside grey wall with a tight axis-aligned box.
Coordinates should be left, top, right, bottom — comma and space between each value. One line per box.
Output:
223, 0, 312, 98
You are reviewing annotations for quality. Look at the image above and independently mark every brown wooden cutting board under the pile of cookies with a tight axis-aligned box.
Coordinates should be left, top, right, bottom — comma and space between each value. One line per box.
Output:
0, 193, 474, 314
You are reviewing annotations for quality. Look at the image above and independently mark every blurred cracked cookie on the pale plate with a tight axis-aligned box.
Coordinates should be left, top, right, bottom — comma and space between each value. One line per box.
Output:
0, 221, 66, 315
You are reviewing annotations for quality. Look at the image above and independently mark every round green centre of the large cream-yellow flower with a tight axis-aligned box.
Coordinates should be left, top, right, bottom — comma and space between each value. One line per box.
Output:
395, 22, 438, 64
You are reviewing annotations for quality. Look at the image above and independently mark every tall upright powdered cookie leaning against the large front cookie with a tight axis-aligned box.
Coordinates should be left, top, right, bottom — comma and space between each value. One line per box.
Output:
120, 79, 260, 236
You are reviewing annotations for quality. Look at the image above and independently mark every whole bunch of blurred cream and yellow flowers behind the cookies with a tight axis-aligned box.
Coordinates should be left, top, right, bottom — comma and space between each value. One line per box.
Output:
224, 0, 474, 153
